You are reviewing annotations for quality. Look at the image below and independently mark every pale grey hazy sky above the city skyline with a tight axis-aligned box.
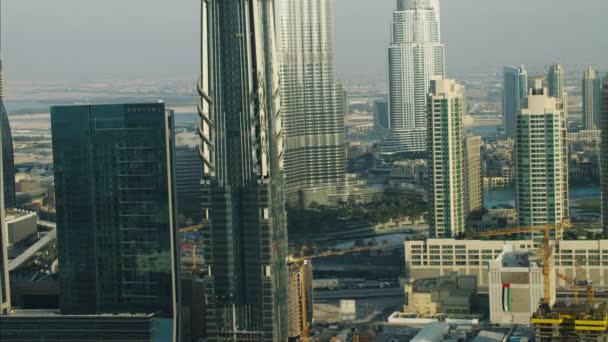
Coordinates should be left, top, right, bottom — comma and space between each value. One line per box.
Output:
3, 0, 608, 82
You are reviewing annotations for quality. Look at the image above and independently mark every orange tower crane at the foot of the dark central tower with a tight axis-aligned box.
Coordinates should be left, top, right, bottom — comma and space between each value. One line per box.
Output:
287, 245, 381, 342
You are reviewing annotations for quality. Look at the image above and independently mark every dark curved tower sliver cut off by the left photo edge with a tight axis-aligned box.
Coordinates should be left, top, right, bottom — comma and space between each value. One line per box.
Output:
0, 3, 17, 208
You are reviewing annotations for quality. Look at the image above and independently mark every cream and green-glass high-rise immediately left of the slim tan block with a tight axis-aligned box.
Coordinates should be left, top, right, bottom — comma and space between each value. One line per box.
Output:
428, 79, 465, 238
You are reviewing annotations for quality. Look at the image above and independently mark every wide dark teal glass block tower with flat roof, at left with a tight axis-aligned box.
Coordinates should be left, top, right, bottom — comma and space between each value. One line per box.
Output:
51, 103, 179, 341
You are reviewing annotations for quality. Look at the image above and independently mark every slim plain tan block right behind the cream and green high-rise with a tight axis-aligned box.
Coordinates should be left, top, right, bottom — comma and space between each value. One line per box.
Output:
464, 135, 483, 216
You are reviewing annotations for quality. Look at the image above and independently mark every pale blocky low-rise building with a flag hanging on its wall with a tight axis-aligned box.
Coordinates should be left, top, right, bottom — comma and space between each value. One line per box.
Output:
488, 245, 556, 325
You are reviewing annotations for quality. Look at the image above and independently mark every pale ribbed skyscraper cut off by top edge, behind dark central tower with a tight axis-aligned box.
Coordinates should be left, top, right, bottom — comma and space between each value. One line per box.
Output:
275, 0, 346, 207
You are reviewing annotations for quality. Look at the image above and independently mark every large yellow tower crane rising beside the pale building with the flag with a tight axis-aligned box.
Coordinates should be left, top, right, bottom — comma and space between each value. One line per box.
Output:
479, 219, 572, 305
